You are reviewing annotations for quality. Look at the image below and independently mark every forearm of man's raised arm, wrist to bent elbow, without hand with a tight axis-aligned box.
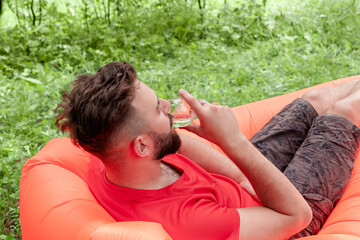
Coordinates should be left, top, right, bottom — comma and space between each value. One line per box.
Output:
221, 134, 309, 223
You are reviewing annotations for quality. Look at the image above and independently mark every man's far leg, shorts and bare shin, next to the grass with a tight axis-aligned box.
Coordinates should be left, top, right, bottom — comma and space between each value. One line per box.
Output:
250, 80, 360, 171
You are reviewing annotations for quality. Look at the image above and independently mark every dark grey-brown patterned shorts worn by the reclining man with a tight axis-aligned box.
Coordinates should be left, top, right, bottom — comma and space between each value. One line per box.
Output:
250, 98, 360, 239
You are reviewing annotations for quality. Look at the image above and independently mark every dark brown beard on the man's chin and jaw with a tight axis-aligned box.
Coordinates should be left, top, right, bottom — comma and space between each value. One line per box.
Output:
150, 115, 181, 160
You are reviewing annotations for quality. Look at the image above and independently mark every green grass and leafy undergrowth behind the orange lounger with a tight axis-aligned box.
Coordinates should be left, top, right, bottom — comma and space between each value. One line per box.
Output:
0, 0, 360, 239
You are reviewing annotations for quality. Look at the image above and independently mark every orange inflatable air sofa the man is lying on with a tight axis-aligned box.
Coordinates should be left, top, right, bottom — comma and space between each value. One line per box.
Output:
20, 75, 360, 240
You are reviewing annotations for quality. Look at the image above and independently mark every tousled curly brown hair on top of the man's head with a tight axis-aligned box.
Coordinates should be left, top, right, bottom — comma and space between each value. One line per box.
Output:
56, 62, 137, 156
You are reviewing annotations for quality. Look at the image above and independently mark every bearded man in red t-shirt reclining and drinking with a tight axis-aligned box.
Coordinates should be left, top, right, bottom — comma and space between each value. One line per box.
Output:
57, 62, 360, 240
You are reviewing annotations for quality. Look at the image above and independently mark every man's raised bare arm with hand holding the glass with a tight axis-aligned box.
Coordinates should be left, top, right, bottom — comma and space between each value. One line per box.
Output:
180, 90, 312, 240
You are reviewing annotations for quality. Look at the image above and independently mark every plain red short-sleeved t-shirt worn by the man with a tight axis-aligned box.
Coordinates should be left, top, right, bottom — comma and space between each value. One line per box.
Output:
89, 154, 261, 240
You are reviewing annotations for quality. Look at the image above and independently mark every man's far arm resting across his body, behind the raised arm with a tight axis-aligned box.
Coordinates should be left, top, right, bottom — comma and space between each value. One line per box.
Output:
178, 134, 258, 199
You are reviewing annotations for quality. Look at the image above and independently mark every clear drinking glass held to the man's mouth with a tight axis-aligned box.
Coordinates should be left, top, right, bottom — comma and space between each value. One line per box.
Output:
169, 98, 195, 128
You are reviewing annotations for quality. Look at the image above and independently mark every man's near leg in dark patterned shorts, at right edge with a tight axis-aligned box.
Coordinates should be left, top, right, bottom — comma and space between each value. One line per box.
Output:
284, 89, 360, 239
